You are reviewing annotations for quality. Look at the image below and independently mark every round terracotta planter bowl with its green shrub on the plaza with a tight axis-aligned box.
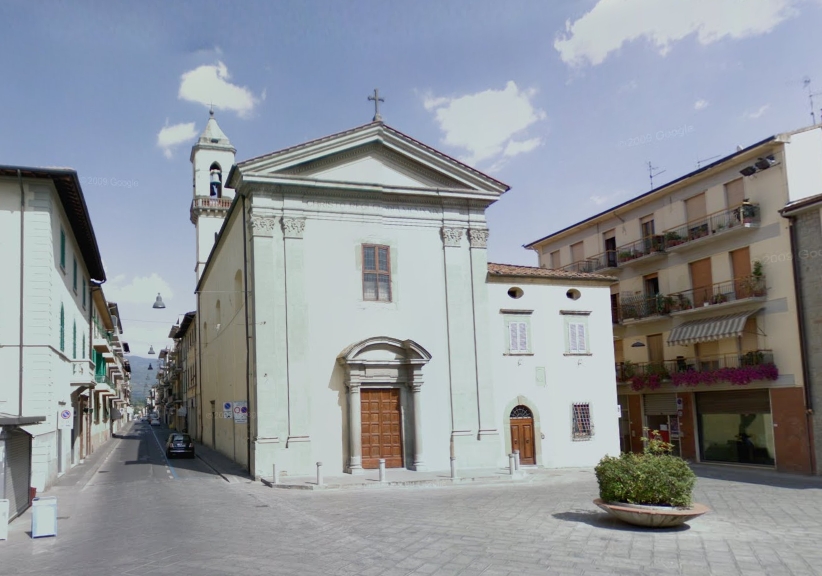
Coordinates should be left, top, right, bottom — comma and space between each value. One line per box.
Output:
594, 428, 708, 528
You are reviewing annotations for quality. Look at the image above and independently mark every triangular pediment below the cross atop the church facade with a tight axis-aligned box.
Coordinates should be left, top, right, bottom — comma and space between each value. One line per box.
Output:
235, 122, 508, 198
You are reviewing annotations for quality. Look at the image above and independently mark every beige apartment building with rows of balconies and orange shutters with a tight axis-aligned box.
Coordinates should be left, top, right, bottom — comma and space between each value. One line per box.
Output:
526, 126, 822, 473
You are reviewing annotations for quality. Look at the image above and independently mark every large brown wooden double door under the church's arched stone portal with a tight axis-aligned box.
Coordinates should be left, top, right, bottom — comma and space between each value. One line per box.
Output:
360, 388, 403, 468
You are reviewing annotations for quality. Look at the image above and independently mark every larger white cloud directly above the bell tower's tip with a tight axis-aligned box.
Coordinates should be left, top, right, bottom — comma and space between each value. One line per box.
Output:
178, 62, 260, 118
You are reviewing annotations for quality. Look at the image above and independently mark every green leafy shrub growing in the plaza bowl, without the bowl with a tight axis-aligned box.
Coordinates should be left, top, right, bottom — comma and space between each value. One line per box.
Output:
595, 435, 696, 508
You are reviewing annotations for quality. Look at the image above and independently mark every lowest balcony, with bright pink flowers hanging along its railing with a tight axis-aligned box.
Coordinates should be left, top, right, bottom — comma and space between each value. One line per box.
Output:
616, 350, 774, 383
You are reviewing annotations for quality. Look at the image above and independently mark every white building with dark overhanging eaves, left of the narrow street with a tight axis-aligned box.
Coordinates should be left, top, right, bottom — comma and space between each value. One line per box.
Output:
0, 166, 127, 519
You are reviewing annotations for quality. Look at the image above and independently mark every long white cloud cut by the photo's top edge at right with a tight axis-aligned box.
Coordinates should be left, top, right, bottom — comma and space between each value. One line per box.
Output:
554, 0, 802, 66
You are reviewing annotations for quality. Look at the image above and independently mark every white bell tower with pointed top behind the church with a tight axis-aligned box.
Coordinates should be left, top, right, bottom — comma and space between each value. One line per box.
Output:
191, 109, 237, 282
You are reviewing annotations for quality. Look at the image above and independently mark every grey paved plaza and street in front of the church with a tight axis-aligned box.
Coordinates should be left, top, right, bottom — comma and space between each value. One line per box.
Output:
0, 424, 822, 576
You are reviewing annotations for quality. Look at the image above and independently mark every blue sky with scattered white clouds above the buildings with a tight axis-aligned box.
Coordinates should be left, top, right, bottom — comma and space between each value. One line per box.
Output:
0, 0, 822, 356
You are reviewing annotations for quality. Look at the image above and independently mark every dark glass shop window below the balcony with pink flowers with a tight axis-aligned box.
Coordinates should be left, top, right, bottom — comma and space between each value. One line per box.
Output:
696, 390, 775, 466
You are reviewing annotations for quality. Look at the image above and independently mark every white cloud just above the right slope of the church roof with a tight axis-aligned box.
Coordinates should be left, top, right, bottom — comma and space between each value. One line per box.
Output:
423, 81, 546, 169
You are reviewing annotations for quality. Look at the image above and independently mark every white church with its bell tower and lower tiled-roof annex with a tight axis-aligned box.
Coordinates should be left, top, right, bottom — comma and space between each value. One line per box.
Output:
189, 113, 619, 478
